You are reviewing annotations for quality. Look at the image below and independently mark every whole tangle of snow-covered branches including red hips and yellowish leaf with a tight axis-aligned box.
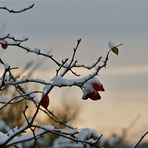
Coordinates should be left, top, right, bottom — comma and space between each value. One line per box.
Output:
0, 4, 126, 148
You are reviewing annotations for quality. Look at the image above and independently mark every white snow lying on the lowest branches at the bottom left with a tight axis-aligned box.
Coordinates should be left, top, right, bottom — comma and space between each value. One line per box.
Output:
0, 119, 103, 148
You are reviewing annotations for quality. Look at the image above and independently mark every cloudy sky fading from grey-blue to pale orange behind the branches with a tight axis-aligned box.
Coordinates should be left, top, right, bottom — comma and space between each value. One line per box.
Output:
0, 0, 148, 138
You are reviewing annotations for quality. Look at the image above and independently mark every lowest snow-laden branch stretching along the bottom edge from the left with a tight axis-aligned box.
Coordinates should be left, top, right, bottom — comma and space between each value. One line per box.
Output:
0, 124, 103, 148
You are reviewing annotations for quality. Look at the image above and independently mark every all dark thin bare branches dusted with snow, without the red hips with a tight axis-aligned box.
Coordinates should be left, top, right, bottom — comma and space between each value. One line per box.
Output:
0, 4, 119, 148
